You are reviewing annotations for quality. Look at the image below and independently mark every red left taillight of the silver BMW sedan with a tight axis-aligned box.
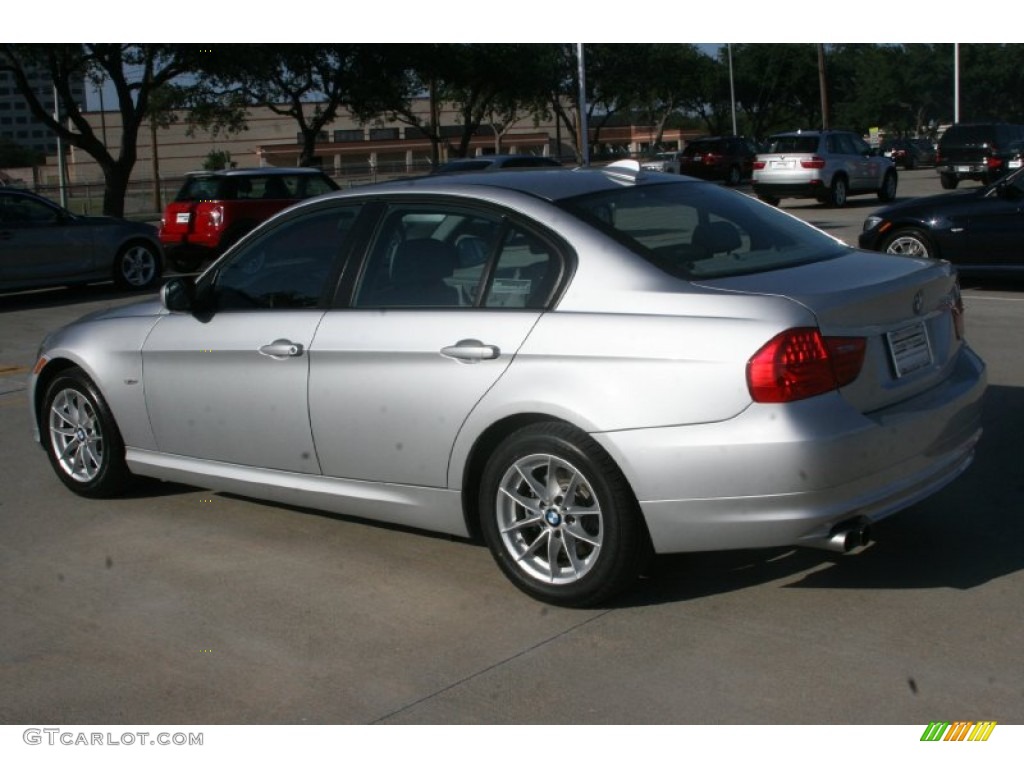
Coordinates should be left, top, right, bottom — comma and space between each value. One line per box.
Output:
746, 328, 866, 402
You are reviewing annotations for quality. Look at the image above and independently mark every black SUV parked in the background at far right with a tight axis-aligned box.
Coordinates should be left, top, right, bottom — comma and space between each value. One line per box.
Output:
935, 123, 1024, 189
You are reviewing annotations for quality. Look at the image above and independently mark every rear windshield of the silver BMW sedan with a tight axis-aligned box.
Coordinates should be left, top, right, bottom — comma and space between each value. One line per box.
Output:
561, 182, 846, 279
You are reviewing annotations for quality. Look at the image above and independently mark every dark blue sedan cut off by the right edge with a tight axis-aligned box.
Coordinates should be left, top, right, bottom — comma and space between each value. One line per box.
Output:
859, 169, 1024, 272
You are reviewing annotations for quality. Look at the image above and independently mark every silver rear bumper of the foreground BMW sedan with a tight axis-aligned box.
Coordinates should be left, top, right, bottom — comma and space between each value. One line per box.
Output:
593, 347, 986, 553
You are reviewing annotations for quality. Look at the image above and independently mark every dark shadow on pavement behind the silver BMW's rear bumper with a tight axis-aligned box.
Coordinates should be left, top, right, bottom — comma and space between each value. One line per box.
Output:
618, 386, 1024, 605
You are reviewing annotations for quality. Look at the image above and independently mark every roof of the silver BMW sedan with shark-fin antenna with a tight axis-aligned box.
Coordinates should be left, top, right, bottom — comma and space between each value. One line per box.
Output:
333, 161, 707, 202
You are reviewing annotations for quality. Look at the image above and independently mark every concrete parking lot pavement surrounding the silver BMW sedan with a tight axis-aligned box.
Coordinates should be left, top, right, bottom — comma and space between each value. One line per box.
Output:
0, 169, 1024, 728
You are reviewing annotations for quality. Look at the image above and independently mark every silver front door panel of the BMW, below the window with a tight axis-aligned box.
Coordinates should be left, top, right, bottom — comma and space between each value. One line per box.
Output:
142, 309, 324, 473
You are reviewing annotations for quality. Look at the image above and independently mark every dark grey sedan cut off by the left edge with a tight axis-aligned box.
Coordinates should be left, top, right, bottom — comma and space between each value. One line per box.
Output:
0, 187, 163, 291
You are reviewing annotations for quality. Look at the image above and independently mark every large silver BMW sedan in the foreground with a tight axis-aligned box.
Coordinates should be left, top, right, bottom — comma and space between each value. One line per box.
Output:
31, 161, 985, 606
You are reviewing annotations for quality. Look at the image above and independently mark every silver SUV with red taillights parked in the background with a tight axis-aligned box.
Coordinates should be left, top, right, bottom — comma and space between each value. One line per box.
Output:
752, 131, 897, 208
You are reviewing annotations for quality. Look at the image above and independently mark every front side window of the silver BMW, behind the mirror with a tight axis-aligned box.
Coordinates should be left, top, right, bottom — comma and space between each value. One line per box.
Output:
197, 205, 360, 310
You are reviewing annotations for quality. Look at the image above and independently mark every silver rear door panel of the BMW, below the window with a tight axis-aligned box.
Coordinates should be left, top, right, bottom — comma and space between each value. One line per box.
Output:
309, 309, 540, 487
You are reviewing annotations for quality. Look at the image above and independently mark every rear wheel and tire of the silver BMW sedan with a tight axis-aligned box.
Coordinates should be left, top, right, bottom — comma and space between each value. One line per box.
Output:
479, 423, 649, 608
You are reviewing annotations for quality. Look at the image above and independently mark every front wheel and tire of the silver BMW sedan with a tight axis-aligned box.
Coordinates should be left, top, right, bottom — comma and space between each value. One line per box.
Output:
39, 368, 131, 499
